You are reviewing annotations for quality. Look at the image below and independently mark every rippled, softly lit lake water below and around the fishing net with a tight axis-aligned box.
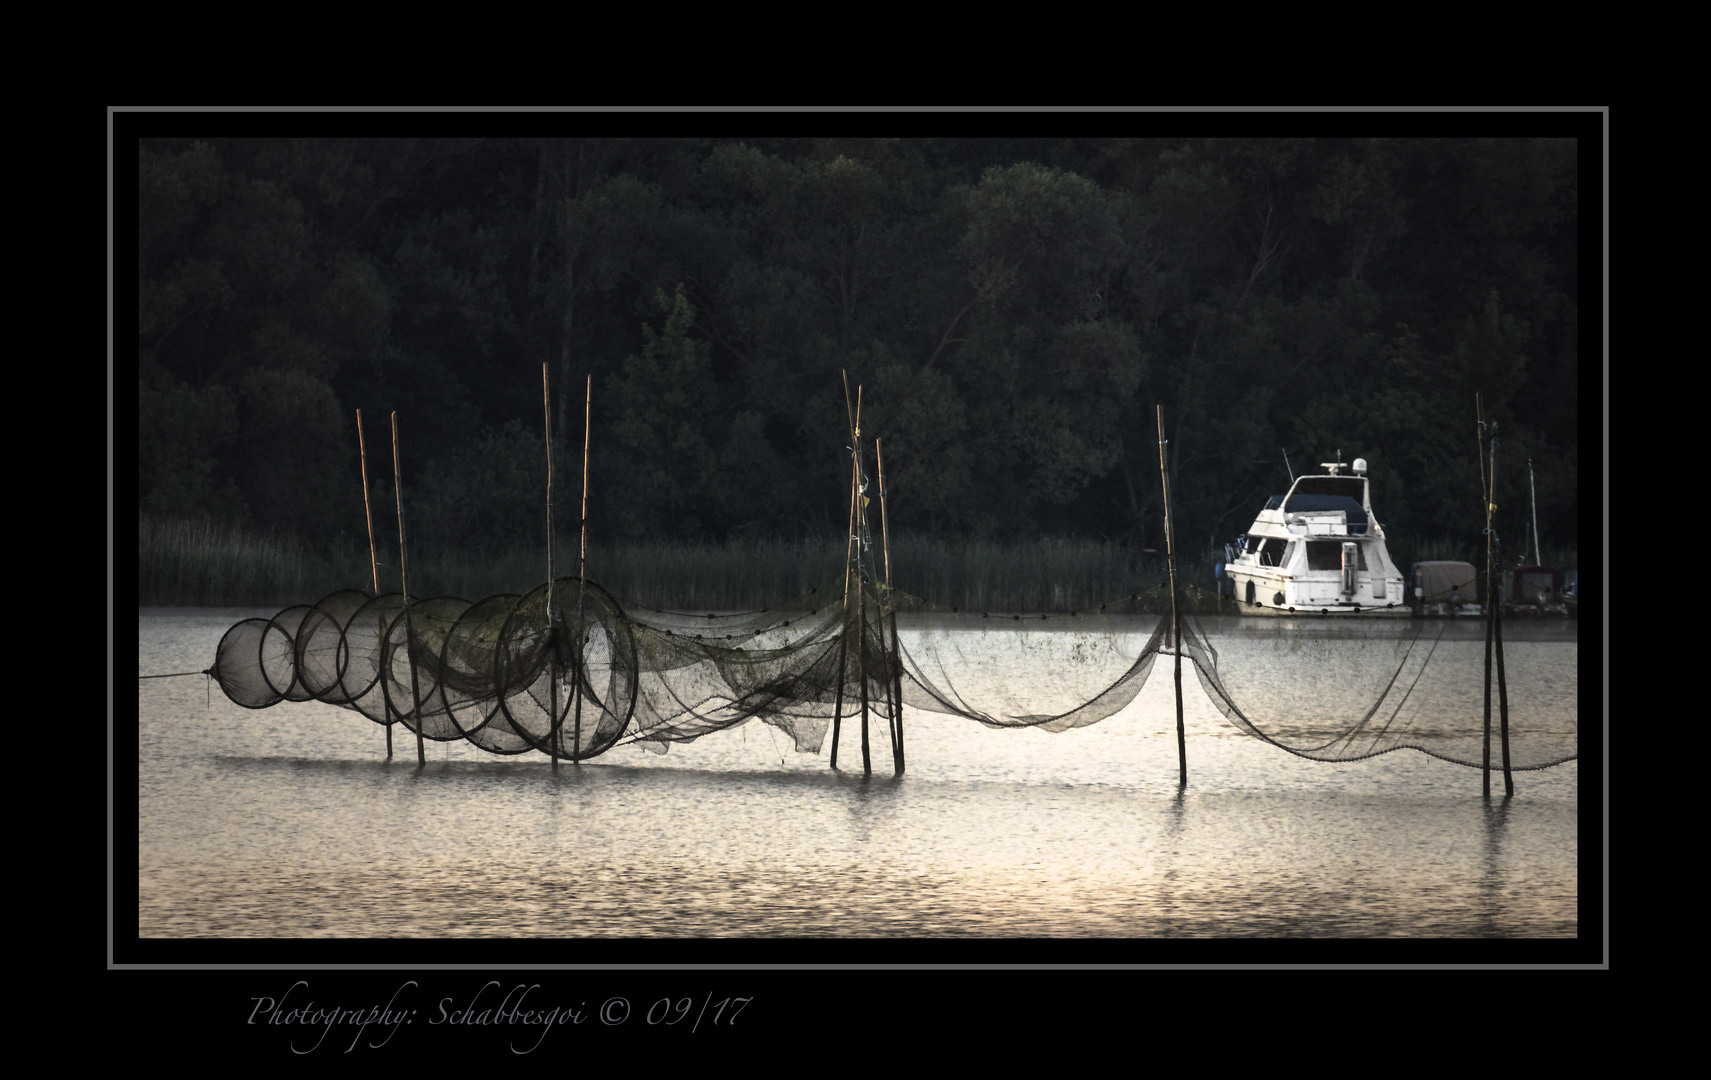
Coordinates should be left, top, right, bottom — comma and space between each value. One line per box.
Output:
133, 609, 1596, 940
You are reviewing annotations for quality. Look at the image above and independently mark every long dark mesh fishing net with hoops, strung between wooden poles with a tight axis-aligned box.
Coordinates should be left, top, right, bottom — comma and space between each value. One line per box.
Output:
210, 572, 1578, 768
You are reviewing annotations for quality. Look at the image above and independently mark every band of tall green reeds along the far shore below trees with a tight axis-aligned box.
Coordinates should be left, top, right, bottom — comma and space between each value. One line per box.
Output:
137, 517, 1576, 613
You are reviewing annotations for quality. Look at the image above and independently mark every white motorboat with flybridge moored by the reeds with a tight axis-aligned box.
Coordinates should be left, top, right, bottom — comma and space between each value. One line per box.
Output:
1223, 454, 1412, 614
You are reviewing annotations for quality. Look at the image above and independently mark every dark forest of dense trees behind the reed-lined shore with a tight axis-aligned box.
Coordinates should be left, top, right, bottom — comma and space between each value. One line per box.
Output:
136, 135, 1601, 581
